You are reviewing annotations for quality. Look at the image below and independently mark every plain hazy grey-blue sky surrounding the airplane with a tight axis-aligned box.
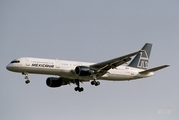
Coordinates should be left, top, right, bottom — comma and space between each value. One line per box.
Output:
0, 0, 179, 120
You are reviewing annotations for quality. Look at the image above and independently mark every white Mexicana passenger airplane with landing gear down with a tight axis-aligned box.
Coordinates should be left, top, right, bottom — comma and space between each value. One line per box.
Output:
6, 43, 169, 92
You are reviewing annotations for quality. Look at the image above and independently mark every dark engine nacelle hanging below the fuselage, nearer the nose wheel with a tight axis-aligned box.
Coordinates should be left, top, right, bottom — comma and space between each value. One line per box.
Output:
46, 77, 68, 87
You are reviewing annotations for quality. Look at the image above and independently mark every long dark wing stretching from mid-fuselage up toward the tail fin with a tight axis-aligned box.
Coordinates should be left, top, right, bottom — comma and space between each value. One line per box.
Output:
90, 50, 142, 74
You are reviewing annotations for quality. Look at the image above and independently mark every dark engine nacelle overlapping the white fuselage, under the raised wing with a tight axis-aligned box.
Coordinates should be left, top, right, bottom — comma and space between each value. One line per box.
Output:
75, 66, 94, 76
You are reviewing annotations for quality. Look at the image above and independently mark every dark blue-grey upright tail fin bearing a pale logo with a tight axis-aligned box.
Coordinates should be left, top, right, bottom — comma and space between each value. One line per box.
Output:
128, 43, 152, 69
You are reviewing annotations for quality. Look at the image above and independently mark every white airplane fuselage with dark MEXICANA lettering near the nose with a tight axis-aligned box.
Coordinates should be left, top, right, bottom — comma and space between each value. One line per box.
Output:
7, 57, 154, 81
